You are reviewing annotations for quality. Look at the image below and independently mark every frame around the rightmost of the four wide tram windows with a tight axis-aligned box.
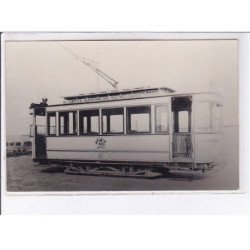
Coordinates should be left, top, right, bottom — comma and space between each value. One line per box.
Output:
126, 104, 152, 135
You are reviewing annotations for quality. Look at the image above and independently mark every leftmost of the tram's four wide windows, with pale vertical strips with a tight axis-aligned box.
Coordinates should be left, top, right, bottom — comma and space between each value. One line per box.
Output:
59, 111, 77, 135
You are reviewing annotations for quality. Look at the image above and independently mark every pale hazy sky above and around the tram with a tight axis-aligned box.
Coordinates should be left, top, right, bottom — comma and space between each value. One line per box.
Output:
5, 40, 239, 135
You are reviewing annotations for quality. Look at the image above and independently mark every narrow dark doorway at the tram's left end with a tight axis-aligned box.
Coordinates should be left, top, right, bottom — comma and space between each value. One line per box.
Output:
33, 108, 46, 158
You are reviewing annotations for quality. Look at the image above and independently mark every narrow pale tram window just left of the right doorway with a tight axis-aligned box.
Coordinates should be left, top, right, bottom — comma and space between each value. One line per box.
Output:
155, 106, 168, 133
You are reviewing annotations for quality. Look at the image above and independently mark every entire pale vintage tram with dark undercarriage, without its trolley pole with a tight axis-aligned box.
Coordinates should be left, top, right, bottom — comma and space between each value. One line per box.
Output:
30, 87, 222, 178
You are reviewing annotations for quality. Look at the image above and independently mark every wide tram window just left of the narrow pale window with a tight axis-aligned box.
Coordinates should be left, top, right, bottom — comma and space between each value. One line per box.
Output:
127, 106, 151, 133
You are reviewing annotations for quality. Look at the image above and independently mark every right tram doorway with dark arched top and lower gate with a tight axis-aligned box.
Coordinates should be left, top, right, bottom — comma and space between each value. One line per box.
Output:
171, 96, 193, 162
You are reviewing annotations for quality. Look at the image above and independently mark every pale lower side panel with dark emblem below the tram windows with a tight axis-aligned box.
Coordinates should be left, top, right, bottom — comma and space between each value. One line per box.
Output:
47, 135, 170, 163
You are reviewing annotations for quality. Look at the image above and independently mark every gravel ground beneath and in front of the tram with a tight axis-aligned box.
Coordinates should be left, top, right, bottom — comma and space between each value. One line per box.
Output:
7, 127, 239, 191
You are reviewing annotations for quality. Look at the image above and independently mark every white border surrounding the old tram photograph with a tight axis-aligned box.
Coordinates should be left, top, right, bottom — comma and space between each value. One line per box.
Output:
1, 32, 250, 214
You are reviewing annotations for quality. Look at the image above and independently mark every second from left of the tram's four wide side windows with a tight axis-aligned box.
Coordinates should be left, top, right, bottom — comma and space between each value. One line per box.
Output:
79, 110, 99, 135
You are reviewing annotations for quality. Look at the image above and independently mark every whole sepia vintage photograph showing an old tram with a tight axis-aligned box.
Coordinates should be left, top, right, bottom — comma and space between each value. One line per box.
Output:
4, 34, 239, 193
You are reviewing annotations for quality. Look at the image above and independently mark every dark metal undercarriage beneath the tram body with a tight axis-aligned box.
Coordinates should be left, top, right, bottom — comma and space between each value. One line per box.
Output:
37, 162, 214, 179
